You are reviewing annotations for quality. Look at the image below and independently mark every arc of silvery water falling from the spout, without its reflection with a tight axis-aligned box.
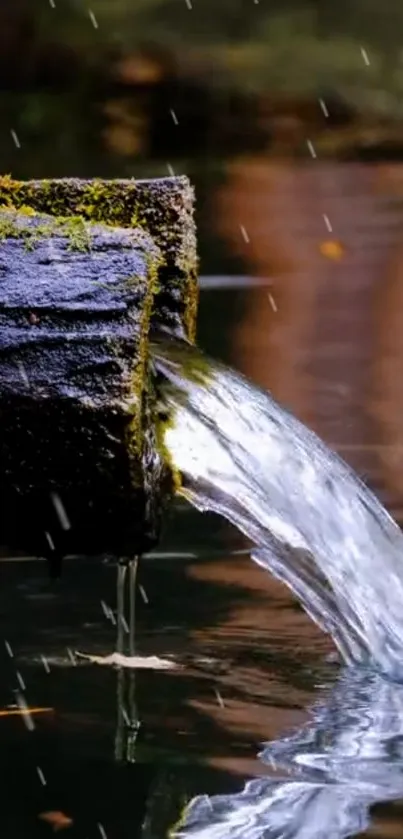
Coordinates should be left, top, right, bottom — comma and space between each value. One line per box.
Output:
153, 338, 403, 678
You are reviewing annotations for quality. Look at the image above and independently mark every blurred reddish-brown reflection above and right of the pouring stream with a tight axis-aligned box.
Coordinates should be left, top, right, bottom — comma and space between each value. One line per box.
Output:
216, 161, 403, 498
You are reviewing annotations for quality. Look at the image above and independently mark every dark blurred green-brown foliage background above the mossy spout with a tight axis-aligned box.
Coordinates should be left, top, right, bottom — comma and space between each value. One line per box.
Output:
0, 0, 403, 271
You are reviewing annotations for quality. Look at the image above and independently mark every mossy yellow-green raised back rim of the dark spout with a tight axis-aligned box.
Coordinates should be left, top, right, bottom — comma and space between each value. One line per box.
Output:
0, 175, 198, 340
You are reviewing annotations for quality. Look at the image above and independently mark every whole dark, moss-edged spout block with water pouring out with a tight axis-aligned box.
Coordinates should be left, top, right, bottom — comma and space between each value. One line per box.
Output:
0, 178, 197, 565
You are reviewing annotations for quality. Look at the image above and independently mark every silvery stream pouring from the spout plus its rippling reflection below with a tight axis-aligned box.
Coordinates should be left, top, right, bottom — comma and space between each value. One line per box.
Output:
154, 338, 403, 839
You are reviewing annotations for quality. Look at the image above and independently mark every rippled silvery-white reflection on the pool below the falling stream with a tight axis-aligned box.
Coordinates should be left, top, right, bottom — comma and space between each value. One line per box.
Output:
175, 669, 403, 839
